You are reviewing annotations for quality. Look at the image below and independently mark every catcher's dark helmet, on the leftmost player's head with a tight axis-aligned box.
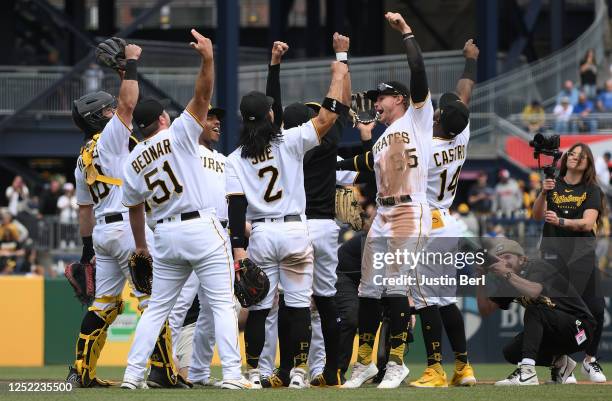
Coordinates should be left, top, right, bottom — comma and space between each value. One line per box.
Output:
72, 91, 116, 138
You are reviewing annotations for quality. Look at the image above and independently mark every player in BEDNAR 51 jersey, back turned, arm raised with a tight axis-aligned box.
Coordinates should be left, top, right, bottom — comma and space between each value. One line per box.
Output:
121, 29, 251, 389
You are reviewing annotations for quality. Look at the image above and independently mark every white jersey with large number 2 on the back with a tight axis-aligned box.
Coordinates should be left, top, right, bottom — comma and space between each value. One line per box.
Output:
225, 120, 319, 220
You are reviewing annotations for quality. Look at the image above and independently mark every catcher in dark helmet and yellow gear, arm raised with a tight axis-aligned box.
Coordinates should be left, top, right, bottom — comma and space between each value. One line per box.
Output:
67, 44, 165, 387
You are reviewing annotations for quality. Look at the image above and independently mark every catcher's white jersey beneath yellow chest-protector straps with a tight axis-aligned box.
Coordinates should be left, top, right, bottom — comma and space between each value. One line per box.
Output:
74, 114, 131, 218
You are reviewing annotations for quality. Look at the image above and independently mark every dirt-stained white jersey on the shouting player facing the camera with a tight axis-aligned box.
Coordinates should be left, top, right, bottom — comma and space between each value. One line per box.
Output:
372, 96, 434, 197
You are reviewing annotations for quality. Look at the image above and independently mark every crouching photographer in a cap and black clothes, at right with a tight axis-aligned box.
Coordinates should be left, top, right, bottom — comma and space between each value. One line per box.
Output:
477, 238, 595, 386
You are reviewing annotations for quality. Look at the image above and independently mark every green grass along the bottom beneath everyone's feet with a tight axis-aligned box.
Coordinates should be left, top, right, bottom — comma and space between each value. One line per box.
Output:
0, 364, 612, 401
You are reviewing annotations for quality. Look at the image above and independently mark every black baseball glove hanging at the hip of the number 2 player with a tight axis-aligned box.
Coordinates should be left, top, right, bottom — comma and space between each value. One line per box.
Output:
234, 258, 270, 308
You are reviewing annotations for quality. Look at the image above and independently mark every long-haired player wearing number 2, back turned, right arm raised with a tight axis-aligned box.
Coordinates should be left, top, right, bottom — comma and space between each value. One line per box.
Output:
226, 62, 348, 388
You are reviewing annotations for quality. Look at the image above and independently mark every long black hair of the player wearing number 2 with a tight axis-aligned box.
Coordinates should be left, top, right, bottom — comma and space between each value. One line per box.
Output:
238, 117, 283, 159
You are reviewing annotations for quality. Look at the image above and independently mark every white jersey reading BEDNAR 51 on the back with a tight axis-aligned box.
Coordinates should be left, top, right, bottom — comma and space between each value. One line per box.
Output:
123, 110, 216, 221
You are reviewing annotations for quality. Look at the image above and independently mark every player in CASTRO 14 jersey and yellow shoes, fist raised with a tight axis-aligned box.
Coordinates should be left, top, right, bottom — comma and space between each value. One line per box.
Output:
410, 39, 478, 387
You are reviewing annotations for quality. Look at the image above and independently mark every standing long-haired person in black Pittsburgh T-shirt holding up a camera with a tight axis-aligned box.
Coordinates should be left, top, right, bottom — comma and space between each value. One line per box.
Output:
533, 143, 606, 382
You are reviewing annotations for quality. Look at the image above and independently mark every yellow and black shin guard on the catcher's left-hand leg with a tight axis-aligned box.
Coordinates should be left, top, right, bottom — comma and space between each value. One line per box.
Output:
74, 297, 123, 387
